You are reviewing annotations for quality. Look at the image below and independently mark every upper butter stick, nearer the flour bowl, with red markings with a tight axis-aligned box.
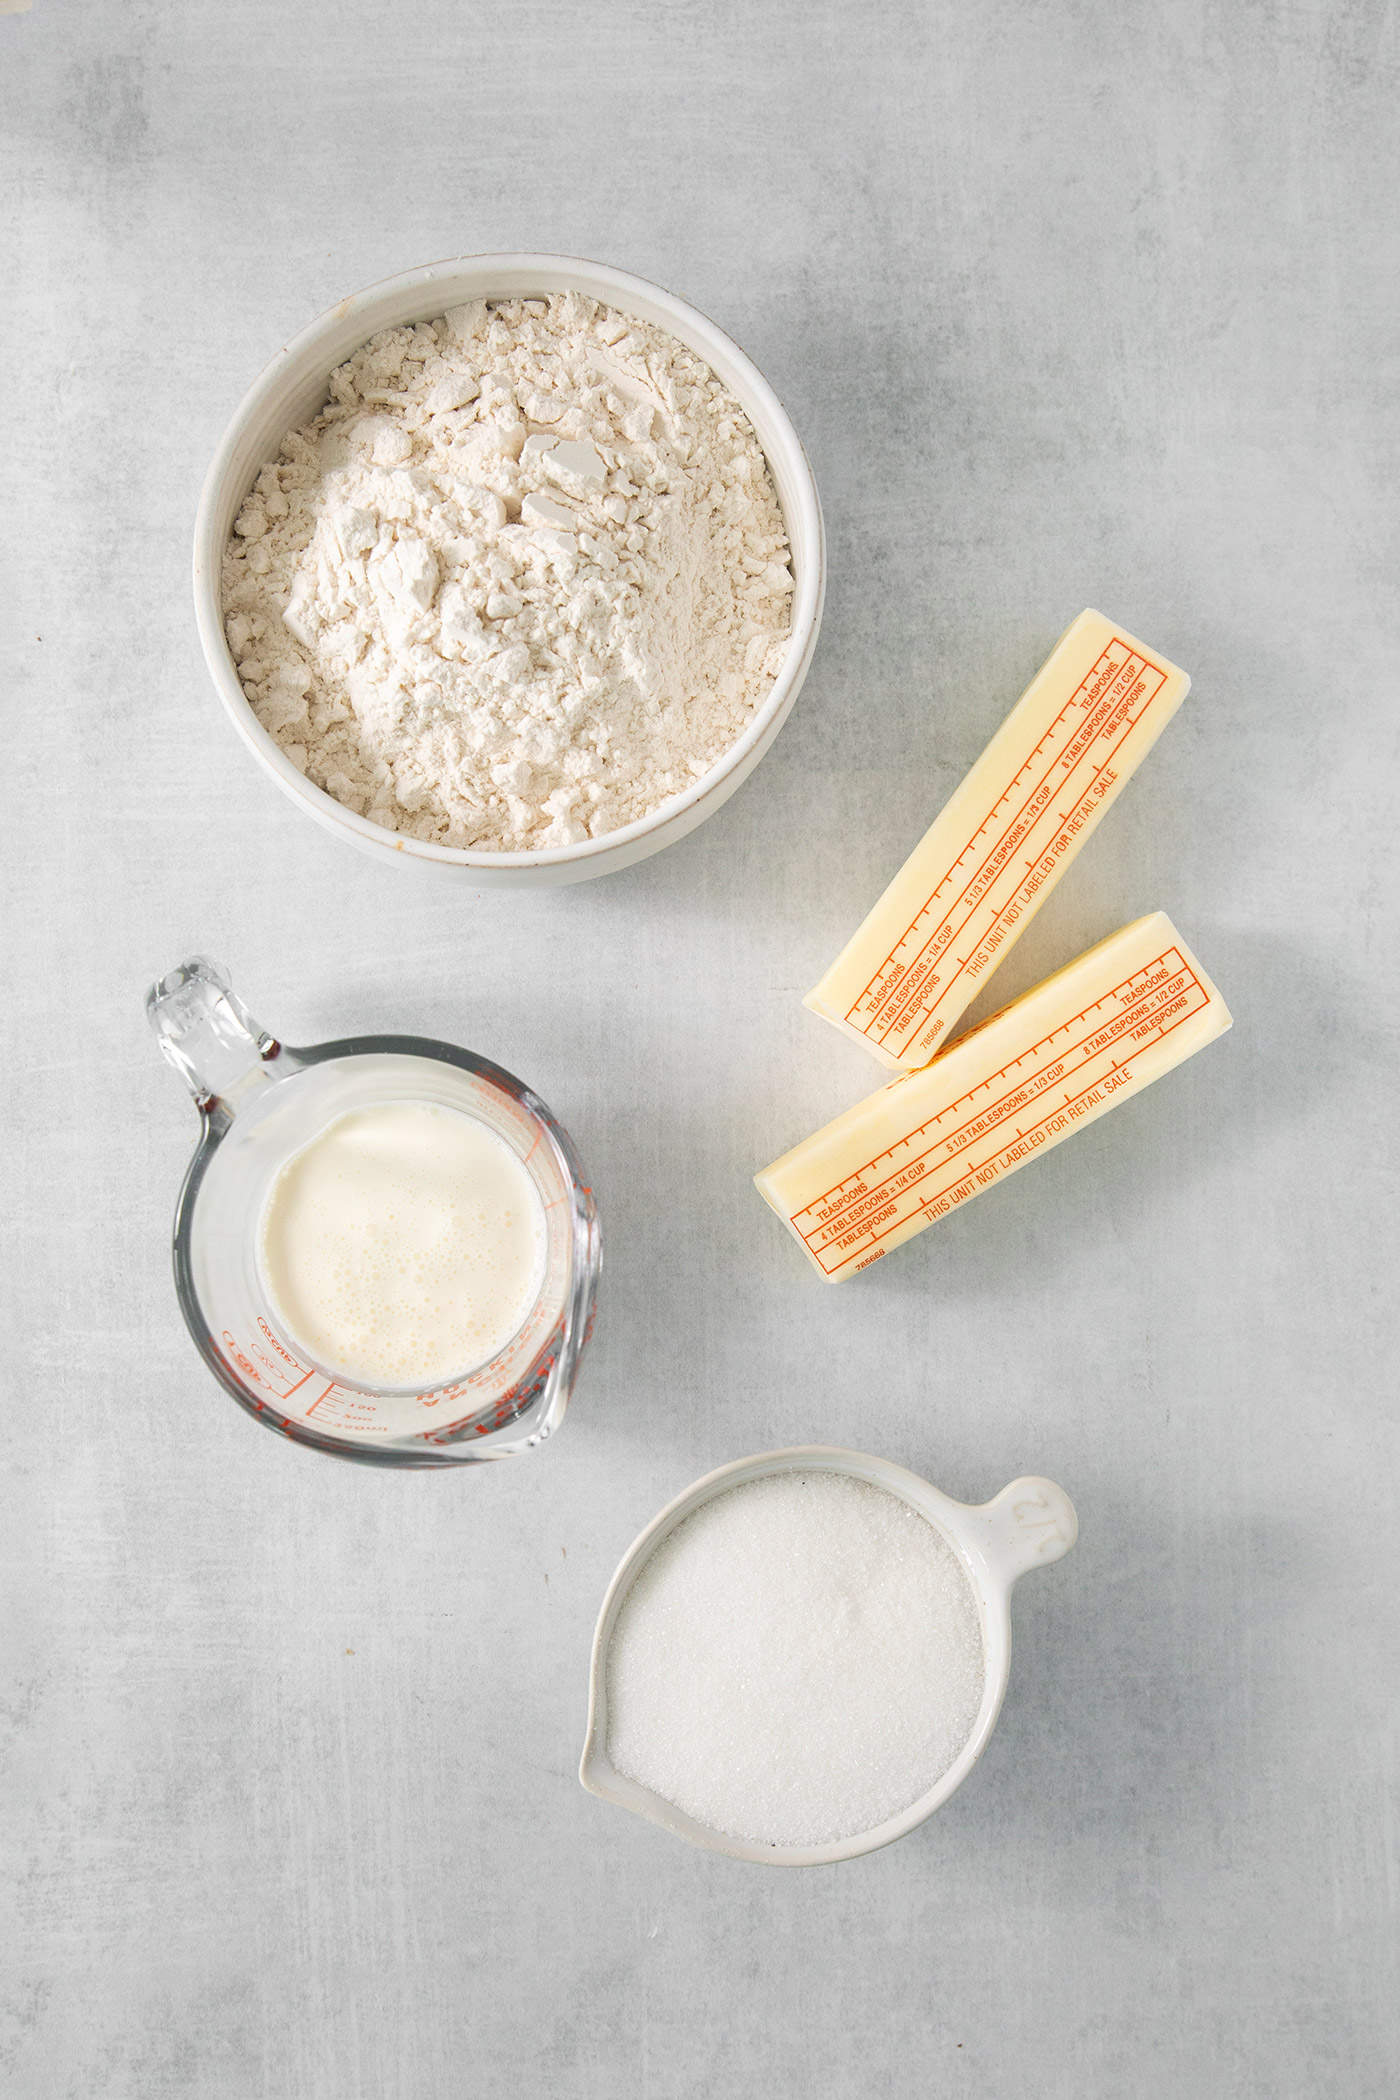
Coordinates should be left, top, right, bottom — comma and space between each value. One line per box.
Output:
802, 613, 1190, 1071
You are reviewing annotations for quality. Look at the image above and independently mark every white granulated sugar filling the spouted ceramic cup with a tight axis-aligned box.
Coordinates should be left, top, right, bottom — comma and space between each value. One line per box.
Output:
607, 1472, 984, 1846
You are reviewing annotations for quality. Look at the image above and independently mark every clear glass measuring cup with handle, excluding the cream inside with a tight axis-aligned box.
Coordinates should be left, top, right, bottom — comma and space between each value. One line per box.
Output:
147, 958, 600, 1466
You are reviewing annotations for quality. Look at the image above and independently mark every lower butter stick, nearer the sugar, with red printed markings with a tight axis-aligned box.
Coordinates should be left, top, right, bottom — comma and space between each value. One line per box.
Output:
754, 911, 1230, 1283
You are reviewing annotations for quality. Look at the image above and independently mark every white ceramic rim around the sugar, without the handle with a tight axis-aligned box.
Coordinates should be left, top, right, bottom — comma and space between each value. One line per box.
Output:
579, 1445, 1014, 1867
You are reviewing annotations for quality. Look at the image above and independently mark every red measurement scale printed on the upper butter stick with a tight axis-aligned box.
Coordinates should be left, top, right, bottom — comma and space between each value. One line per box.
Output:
846, 634, 1167, 1044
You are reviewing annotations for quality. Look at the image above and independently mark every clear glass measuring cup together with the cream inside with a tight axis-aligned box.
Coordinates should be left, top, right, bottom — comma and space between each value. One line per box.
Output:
147, 958, 600, 1466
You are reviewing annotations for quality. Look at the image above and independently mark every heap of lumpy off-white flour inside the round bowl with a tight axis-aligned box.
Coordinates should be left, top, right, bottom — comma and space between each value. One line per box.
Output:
222, 294, 793, 851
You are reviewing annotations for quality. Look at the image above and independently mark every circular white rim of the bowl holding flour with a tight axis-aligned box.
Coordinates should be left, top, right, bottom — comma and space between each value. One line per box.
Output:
193, 250, 827, 872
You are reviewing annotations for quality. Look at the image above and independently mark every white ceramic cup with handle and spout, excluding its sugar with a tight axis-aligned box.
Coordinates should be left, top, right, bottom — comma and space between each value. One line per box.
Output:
579, 1445, 1079, 1867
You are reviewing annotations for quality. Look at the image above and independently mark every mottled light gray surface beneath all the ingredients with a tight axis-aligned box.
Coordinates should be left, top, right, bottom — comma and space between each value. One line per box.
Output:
0, 0, 1400, 2100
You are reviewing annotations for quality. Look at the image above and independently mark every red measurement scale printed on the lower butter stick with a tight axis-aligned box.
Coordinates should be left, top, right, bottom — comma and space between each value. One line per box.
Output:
791, 947, 1209, 1275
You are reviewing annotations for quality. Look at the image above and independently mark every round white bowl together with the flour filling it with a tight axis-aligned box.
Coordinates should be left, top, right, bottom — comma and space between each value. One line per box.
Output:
195, 256, 825, 886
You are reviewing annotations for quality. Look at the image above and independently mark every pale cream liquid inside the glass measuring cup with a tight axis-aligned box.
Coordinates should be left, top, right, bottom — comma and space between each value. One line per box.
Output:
258, 1100, 546, 1386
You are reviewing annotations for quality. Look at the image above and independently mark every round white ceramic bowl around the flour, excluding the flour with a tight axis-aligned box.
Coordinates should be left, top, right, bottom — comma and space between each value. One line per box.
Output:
195, 254, 827, 888
